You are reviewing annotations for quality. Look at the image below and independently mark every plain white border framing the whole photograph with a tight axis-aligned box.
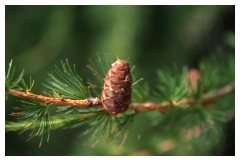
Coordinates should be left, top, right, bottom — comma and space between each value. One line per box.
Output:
0, 0, 240, 161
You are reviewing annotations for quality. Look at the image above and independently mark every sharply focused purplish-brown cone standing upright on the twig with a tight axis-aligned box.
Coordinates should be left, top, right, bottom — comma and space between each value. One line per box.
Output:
102, 59, 132, 115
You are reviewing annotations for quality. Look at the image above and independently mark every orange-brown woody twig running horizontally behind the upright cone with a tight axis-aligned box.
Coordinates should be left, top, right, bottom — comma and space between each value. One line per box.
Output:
7, 83, 235, 113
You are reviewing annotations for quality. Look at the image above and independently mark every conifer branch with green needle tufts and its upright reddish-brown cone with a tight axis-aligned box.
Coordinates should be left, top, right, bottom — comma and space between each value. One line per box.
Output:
5, 52, 235, 146
